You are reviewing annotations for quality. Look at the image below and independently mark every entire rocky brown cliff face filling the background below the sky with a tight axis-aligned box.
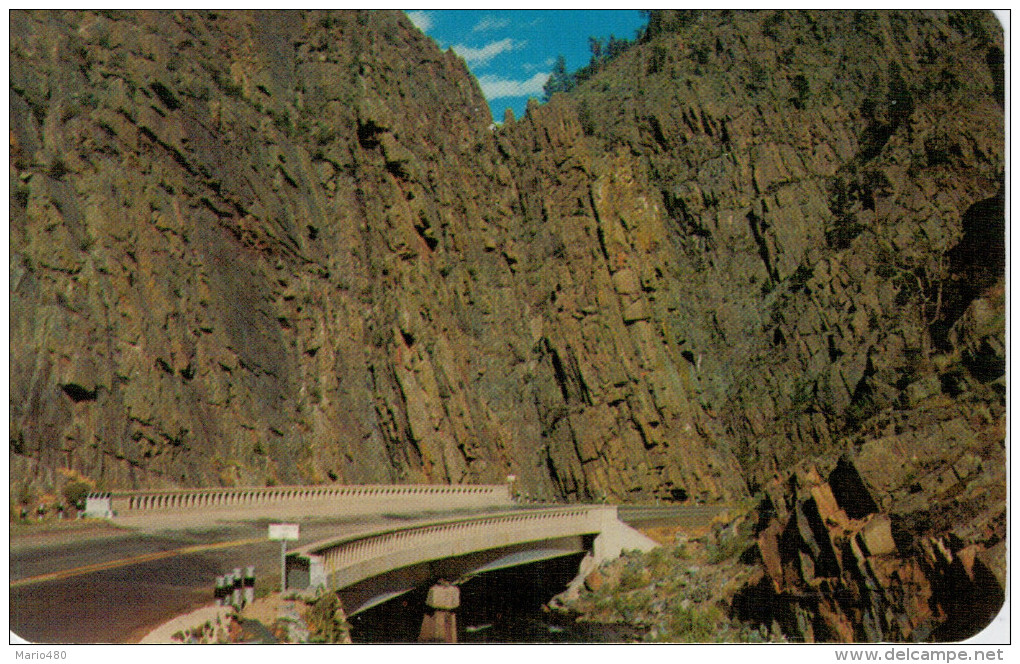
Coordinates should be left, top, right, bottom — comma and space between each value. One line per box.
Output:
10, 12, 1005, 526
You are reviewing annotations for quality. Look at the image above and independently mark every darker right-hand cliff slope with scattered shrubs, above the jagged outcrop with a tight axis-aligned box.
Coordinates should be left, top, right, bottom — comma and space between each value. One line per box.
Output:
576, 11, 1005, 477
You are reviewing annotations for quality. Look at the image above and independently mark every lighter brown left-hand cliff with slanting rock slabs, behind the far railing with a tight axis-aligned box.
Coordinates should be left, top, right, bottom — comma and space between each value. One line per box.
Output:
10, 12, 744, 499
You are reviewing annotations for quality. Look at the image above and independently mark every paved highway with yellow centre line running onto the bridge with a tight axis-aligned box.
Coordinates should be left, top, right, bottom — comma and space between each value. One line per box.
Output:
9, 506, 720, 644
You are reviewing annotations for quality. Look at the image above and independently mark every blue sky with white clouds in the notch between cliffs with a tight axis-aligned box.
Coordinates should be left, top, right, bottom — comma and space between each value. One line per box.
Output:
407, 9, 645, 121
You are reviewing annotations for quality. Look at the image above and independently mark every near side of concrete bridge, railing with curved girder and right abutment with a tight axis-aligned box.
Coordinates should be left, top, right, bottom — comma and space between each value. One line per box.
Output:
287, 505, 656, 616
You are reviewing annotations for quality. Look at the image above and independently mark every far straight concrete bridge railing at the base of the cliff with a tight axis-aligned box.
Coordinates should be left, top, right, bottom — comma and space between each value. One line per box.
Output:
86, 484, 513, 516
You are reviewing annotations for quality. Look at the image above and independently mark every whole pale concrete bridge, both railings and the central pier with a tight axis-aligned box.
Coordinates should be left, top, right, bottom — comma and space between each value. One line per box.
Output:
86, 484, 656, 641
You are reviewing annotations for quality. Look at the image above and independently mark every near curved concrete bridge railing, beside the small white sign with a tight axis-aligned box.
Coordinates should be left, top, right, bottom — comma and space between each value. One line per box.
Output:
288, 506, 617, 590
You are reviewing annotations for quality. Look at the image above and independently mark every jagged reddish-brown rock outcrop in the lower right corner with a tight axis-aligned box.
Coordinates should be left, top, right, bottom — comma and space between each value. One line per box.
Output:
731, 452, 1006, 643
